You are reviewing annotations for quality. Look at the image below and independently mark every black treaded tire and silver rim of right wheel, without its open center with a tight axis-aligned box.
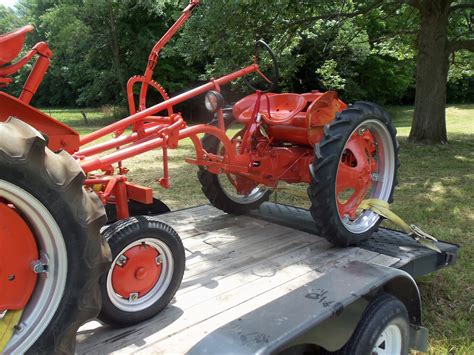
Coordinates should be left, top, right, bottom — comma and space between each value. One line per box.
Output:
308, 102, 400, 247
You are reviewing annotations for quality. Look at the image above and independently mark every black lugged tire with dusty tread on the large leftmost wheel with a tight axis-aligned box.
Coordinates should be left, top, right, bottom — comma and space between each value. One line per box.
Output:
0, 118, 110, 354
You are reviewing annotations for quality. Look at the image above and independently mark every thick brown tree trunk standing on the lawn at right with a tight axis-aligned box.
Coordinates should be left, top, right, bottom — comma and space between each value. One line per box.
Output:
409, 0, 450, 144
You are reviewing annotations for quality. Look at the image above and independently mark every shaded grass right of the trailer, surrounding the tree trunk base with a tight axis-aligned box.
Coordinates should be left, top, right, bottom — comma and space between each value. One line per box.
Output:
388, 105, 474, 354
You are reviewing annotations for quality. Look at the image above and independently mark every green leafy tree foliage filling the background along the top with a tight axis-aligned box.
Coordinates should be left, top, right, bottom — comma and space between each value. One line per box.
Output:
0, 0, 474, 134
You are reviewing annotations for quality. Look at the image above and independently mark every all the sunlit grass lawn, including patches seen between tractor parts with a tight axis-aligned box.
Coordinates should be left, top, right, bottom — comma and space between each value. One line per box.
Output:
53, 105, 474, 354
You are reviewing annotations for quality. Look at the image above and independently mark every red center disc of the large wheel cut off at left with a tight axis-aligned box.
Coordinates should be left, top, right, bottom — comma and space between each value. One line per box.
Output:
0, 202, 38, 311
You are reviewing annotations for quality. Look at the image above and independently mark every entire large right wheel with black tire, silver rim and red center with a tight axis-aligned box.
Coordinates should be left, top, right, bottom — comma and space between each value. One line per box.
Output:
308, 102, 399, 246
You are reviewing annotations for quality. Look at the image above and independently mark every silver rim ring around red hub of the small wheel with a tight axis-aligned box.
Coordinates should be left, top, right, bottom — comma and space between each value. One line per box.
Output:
107, 238, 174, 312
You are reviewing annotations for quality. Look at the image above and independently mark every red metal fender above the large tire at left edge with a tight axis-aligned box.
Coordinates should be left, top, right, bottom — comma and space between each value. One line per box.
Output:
0, 91, 79, 154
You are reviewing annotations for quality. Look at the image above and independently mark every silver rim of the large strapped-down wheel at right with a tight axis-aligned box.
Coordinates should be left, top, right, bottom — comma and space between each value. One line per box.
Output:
335, 119, 395, 234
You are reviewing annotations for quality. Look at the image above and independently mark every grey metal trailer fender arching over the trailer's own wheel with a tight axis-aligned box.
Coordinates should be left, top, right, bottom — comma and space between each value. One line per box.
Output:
189, 261, 427, 354
